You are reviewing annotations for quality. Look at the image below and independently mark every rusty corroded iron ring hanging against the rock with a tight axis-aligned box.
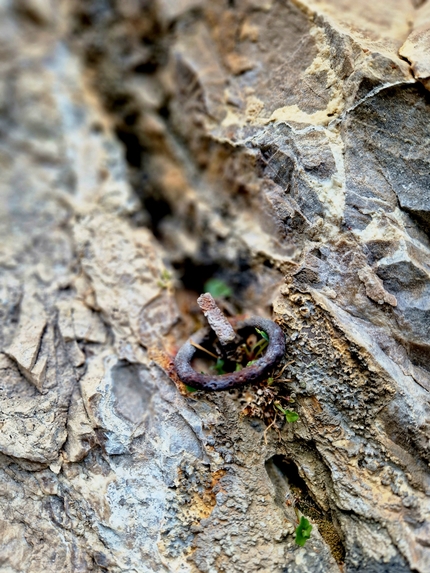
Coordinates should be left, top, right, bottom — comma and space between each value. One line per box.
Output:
175, 316, 285, 391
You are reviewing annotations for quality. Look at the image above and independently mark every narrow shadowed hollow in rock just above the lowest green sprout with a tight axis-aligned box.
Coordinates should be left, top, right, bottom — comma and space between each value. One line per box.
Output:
265, 455, 345, 564
